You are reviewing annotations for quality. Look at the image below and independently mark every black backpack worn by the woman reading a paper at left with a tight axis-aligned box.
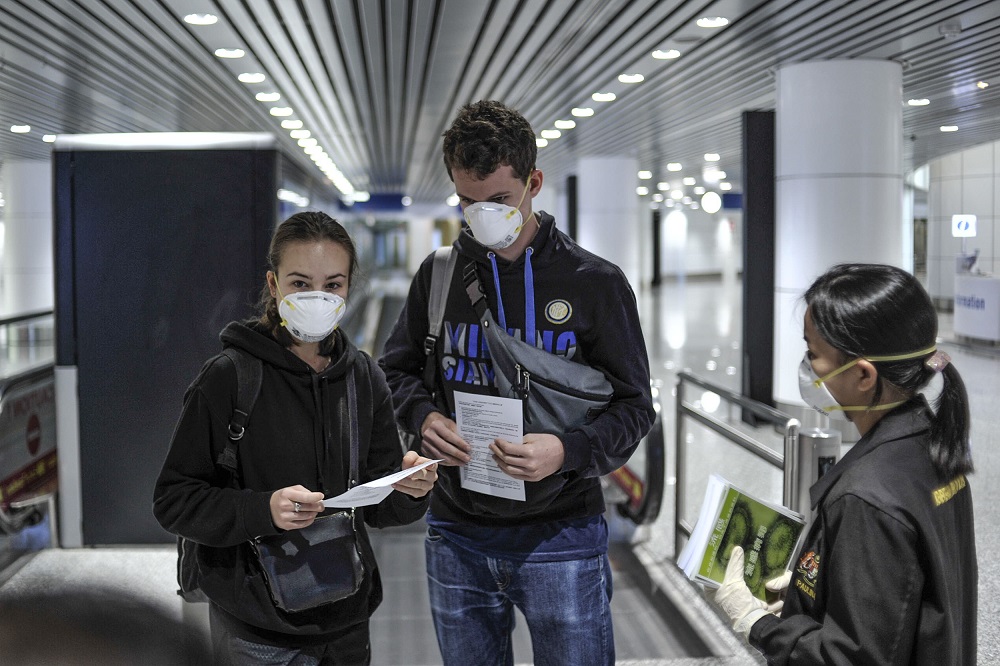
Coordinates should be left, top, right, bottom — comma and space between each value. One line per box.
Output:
177, 347, 263, 601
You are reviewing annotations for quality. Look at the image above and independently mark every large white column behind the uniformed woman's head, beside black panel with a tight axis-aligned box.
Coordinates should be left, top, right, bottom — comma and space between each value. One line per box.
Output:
774, 60, 912, 405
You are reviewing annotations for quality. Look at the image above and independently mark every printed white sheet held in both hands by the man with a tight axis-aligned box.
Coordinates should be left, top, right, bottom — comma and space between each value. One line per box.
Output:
455, 391, 524, 502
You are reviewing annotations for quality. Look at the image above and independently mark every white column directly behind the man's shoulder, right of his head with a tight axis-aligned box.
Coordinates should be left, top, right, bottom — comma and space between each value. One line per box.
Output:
577, 157, 648, 293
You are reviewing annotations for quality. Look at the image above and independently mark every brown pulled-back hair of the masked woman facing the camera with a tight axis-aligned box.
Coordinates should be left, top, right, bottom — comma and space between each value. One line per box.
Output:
257, 211, 358, 355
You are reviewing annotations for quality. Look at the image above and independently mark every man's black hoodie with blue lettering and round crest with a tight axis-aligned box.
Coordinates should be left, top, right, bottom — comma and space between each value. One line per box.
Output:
379, 213, 655, 526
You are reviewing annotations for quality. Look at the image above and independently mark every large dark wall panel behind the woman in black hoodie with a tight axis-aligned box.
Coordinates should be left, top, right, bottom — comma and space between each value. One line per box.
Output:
56, 150, 278, 544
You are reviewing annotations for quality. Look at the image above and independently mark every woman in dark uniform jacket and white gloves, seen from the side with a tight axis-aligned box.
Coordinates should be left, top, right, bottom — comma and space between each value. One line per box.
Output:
715, 264, 977, 664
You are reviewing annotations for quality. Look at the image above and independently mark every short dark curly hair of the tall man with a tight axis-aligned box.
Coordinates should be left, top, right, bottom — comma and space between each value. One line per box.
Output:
443, 100, 538, 181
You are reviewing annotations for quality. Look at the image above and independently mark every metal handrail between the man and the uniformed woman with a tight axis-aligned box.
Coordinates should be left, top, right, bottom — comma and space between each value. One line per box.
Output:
674, 372, 801, 557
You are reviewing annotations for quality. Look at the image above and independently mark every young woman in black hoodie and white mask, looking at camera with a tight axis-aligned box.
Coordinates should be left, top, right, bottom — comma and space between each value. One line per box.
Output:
154, 212, 437, 664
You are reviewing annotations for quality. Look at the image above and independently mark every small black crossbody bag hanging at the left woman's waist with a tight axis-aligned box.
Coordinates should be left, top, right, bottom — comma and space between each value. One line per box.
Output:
250, 368, 365, 613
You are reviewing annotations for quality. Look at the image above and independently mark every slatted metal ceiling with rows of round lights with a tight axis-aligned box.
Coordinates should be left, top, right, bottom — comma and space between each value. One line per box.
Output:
0, 0, 1000, 204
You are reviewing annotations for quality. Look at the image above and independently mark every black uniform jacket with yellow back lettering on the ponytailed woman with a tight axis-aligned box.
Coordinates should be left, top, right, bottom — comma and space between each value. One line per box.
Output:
750, 398, 978, 666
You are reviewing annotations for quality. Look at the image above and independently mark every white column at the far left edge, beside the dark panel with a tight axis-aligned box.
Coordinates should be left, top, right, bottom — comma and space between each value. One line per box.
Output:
0, 160, 55, 315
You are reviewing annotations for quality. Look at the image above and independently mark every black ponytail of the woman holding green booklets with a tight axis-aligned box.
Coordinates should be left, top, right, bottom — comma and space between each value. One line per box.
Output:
930, 363, 973, 479
